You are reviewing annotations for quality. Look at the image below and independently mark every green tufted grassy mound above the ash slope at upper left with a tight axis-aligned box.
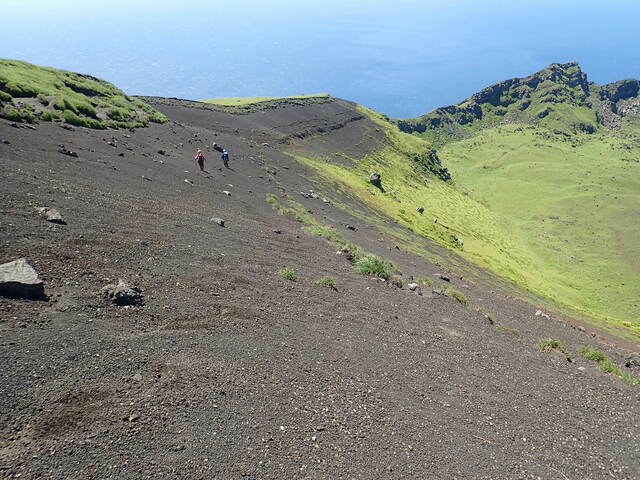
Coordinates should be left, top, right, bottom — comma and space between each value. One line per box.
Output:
0, 59, 168, 129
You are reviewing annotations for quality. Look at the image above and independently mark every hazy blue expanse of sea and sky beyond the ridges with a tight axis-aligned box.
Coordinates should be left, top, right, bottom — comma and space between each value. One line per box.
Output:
0, 0, 640, 117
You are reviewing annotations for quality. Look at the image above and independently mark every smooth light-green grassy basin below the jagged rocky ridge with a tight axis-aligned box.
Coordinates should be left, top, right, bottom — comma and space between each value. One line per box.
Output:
440, 125, 640, 336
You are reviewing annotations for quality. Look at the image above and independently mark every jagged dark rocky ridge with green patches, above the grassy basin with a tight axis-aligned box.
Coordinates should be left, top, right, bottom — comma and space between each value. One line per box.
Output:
397, 62, 640, 137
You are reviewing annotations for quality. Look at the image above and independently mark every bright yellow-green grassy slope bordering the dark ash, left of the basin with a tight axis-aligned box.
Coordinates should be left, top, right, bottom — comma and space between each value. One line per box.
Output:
291, 107, 542, 291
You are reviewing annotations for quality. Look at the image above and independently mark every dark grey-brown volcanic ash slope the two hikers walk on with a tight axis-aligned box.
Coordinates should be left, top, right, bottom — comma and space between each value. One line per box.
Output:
0, 100, 640, 479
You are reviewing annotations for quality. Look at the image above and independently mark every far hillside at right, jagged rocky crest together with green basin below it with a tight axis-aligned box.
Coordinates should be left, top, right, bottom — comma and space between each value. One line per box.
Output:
390, 63, 640, 336
